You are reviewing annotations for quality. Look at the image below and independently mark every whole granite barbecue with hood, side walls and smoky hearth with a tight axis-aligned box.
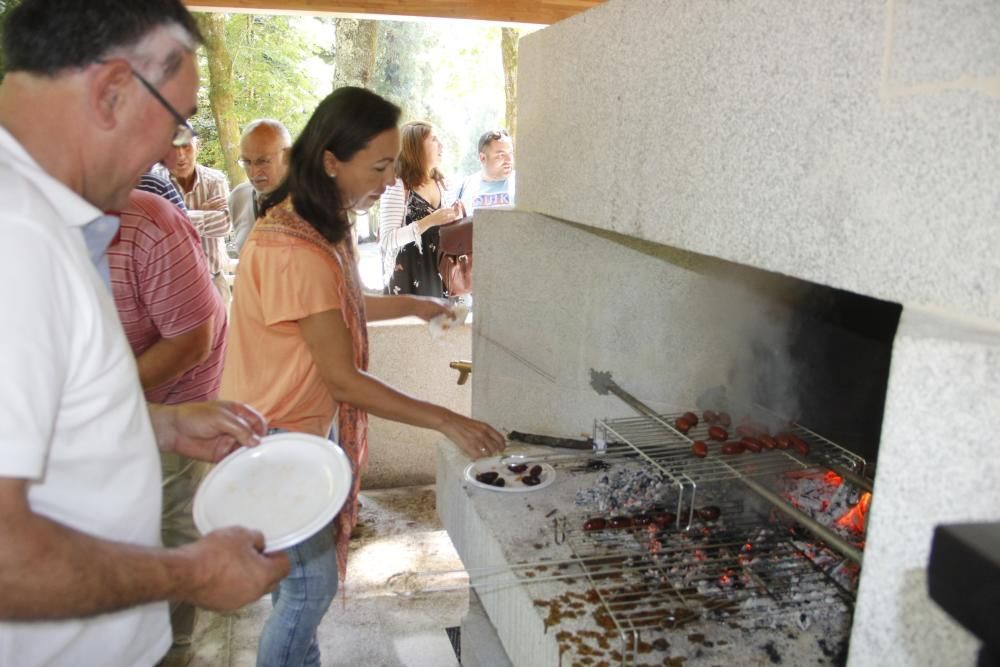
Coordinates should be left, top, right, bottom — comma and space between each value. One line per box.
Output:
438, 0, 1000, 667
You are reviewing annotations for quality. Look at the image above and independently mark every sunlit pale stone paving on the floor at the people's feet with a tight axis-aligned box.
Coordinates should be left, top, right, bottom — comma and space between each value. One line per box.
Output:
164, 486, 469, 667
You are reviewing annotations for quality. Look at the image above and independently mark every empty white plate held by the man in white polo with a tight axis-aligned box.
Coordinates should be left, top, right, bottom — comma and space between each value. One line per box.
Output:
193, 433, 351, 553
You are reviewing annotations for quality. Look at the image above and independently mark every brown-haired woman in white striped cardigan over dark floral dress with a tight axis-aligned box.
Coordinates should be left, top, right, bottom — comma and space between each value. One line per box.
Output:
379, 120, 464, 296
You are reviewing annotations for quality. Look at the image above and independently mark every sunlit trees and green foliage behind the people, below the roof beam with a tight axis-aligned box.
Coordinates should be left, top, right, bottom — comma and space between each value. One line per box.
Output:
193, 14, 532, 188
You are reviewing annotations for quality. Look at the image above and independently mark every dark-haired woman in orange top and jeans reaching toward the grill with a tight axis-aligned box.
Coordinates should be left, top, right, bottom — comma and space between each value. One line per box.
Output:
221, 88, 504, 667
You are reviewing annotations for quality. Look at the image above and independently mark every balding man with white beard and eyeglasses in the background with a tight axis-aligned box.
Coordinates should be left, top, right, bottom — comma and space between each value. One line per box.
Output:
229, 118, 292, 253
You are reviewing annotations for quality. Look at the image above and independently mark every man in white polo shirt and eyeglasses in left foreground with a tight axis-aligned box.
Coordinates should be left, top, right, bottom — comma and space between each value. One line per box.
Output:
0, 0, 288, 667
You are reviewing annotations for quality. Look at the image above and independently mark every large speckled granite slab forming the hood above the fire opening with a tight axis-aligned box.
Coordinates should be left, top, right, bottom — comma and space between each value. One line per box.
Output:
517, 0, 1000, 319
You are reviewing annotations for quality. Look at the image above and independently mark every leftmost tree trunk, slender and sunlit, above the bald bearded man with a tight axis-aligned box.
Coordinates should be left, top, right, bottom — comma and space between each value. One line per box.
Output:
195, 13, 246, 185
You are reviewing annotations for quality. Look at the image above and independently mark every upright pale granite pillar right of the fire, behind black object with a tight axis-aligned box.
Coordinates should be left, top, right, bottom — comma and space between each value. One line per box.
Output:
848, 308, 1000, 667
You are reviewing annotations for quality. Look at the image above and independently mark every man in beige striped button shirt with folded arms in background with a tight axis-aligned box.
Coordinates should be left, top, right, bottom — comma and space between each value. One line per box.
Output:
153, 136, 232, 308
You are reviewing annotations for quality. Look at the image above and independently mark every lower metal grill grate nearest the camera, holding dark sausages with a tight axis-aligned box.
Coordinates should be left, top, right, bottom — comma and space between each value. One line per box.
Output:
566, 506, 857, 664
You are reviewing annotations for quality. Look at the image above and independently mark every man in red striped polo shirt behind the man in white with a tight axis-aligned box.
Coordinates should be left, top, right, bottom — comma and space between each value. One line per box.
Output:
107, 189, 228, 651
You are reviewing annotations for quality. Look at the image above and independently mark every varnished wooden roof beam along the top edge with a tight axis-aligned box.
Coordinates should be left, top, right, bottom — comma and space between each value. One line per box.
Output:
184, 0, 604, 25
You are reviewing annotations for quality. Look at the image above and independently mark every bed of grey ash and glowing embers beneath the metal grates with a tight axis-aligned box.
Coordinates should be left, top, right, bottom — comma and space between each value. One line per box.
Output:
559, 463, 857, 665
